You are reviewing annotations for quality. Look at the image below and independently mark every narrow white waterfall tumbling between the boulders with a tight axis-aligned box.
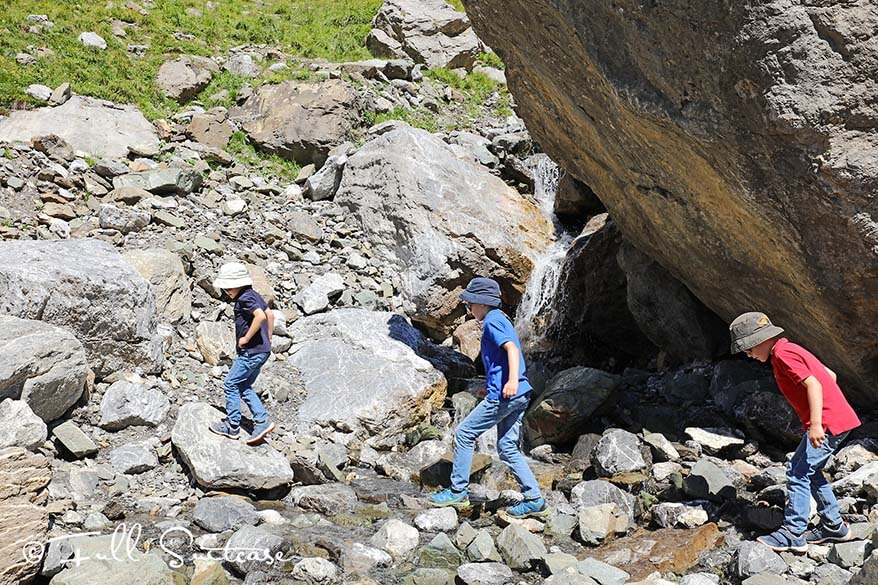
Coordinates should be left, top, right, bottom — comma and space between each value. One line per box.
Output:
515, 157, 574, 352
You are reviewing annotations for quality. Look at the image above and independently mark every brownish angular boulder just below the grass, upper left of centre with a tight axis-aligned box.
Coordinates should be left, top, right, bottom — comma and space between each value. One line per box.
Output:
230, 79, 359, 166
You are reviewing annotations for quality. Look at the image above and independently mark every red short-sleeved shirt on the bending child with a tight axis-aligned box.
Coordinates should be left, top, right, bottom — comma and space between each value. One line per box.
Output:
771, 337, 860, 435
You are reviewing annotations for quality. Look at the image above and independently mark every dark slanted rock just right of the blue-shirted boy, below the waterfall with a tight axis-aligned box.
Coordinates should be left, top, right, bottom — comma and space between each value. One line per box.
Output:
524, 367, 619, 446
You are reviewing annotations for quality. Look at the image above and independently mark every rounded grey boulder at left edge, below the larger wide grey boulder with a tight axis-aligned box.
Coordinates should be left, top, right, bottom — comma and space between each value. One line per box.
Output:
0, 318, 88, 422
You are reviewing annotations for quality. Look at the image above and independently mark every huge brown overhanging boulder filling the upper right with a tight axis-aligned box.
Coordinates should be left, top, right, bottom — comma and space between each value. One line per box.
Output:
464, 0, 878, 405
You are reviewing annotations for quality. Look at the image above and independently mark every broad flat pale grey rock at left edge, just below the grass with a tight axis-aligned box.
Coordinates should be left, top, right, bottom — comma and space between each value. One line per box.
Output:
0, 96, 159, 158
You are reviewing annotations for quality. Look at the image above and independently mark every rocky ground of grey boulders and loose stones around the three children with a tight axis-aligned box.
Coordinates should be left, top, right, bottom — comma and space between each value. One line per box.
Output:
0, 0, 878, 585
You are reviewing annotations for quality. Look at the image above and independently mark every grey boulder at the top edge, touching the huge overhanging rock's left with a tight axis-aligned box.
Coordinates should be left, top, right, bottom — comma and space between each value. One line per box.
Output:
366, 0, 484, 69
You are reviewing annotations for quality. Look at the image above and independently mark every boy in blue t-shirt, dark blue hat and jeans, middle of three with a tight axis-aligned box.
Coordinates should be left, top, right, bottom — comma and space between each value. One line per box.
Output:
430, 278, 548, 518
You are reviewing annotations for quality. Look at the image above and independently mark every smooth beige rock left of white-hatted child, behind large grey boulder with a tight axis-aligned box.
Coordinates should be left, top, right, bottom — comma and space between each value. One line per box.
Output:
123, 248, 192, 323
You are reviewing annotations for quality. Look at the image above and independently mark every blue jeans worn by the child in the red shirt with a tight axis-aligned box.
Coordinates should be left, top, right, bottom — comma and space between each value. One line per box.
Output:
784, 431, 848, 534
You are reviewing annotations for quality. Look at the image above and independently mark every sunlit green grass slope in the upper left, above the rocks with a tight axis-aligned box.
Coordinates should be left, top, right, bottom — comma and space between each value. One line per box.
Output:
0, 0, 382, 119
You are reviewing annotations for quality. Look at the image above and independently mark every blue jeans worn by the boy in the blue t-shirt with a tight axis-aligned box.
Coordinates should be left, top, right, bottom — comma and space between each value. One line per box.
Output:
451, 392, 541, 500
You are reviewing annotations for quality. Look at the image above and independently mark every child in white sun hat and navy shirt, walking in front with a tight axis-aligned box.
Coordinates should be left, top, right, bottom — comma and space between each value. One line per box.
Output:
210, 262, 275, 445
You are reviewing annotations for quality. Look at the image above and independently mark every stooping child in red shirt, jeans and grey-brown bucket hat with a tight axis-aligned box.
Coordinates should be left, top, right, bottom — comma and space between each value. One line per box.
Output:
729, 313, 860, 552
